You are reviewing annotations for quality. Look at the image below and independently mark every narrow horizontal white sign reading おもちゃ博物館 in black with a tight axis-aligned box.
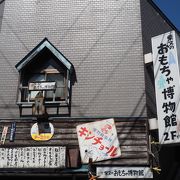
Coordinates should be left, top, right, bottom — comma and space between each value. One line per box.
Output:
96, 167, 153, 179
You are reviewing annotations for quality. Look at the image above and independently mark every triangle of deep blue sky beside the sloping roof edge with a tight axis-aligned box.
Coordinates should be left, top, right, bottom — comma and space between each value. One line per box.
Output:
153, 0, 180, 31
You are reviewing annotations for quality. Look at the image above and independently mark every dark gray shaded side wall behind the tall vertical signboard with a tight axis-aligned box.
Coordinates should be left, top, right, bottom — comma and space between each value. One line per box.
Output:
140, 0, 172, 118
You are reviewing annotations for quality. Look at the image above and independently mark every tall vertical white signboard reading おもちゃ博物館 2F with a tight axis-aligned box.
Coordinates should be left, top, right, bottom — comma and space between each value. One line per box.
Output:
152, 31, 180, 144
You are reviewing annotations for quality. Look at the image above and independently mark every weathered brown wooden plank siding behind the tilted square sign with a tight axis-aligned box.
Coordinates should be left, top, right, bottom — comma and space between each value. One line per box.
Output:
0, 118, 149, 169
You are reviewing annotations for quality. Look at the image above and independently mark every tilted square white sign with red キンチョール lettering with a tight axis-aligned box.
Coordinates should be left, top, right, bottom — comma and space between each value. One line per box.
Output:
76, 119, 121, 163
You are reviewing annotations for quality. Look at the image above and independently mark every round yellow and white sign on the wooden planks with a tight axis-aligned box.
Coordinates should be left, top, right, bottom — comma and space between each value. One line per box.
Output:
31, 123, 54, 141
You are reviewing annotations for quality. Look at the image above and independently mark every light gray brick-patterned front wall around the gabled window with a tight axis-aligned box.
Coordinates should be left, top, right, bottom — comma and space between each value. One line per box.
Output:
0, 0, 146, 118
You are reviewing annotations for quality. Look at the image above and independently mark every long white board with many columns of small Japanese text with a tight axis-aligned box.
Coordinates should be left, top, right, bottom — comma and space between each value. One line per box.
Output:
0, 146, 66, 168
